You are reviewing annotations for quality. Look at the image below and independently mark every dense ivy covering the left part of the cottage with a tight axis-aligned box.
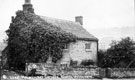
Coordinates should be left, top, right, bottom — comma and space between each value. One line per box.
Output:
6, 11, 76, 68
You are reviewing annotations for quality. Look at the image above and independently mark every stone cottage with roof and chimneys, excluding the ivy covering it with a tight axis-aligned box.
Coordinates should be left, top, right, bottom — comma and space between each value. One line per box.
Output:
13, 0, 98, 65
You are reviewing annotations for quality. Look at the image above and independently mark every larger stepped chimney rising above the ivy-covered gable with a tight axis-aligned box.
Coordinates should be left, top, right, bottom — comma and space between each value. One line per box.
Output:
23, 0, 34, 13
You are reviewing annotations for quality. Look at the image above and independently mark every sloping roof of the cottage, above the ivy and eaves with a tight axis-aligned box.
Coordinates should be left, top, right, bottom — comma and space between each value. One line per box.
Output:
40, 16, 98, 40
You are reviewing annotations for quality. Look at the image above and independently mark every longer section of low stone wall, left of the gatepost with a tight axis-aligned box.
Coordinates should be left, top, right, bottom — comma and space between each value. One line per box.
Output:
26, 63, 105, 79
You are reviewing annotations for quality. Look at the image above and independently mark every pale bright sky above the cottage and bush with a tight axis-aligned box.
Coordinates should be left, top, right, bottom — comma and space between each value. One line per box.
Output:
0, 0, 135, 48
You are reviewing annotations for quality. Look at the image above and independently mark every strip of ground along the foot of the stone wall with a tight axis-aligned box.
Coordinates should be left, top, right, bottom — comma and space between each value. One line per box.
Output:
0, 70, 135, 80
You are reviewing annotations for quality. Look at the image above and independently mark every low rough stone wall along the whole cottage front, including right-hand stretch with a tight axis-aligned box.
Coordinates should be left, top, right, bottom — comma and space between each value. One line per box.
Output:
26, 63, 135, 79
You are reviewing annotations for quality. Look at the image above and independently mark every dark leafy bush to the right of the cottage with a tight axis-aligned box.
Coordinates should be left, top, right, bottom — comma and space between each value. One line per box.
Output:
98, 37, 135, 68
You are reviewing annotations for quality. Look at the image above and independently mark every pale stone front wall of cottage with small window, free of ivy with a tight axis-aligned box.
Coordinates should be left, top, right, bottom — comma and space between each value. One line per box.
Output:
57, 40, 97, 65
